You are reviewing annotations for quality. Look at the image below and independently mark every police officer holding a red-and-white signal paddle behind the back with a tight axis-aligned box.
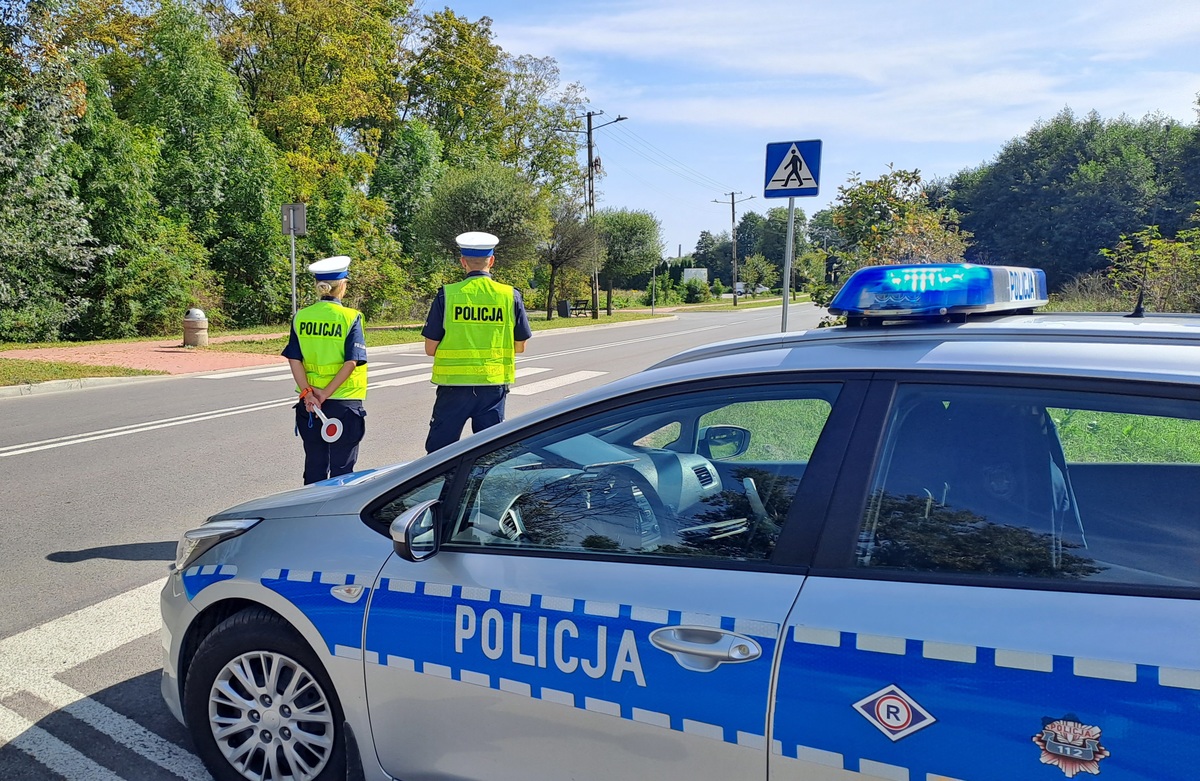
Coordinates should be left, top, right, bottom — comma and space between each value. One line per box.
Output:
283, 256, 367, 485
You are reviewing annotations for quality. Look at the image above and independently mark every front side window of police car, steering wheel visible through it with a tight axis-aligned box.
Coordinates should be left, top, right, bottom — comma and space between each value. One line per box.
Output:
448, 383, 839, 560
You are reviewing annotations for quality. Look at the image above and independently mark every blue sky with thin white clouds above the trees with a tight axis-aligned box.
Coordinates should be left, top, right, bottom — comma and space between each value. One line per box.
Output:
432, 0, 1200, 257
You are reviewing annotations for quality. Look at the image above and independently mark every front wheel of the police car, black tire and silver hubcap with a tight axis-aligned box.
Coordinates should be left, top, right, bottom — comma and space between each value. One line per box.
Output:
184, 608, 346, 781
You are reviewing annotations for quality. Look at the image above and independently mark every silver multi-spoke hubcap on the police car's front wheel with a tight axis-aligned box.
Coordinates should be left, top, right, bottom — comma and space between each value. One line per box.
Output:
209, 651, 334, 781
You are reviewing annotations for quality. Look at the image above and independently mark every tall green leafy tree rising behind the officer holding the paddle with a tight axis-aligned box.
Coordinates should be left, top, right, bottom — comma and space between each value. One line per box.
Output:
127, 4, 290, 325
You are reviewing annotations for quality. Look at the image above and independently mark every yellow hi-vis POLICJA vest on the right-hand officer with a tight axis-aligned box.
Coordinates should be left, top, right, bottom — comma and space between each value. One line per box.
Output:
433, 275, 516, 385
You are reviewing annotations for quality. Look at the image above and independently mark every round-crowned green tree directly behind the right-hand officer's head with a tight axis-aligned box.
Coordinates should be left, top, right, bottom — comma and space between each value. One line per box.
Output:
414, 162, 550, 295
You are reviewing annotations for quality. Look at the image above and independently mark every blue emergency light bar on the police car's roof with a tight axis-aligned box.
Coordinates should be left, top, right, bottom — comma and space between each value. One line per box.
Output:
829, 263, 1050, 323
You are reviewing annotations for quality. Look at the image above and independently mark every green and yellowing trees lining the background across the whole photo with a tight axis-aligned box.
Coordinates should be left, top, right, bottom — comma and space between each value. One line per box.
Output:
0, 0, 1200, 342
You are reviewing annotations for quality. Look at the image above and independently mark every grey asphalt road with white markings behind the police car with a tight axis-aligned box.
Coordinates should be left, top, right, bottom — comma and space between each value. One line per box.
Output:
0, 304, 823, 781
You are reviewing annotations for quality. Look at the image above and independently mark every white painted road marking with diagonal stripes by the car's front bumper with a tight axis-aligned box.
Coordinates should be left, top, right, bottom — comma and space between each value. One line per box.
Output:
0, 581, 210, 781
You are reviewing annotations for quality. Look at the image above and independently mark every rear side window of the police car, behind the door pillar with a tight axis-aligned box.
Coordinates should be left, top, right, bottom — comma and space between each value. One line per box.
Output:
857, 385, 1200, 588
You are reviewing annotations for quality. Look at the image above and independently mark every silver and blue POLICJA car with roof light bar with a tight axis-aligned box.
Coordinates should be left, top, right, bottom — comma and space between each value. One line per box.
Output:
162, 265, 1200, 781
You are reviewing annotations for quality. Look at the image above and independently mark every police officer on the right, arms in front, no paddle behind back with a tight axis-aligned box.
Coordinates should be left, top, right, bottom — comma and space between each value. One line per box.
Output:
421, 232, 533, 452
